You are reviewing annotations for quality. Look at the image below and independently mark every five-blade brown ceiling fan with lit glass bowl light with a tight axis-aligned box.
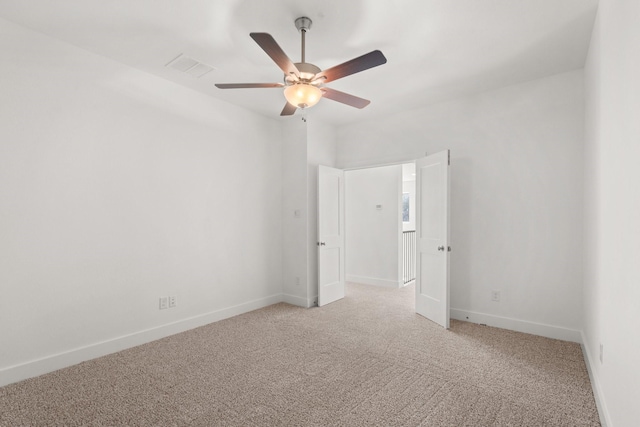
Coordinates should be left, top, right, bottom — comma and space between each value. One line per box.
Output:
216, 16, 387, 116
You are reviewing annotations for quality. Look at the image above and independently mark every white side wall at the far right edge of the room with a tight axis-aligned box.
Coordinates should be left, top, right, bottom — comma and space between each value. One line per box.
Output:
584, 0, 640, 426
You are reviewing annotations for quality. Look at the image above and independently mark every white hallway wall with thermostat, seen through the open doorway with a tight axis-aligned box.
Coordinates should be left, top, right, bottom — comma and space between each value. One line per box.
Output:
345, 165, 402, 288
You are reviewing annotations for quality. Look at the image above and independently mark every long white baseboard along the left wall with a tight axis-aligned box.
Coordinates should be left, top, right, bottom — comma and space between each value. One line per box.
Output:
0, 294, 283, 387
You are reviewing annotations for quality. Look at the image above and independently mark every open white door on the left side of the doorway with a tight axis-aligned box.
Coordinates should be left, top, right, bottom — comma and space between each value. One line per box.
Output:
318, 166, 345, 307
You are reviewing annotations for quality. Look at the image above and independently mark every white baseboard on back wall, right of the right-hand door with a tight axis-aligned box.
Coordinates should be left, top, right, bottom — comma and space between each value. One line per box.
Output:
450, 308, 582, 343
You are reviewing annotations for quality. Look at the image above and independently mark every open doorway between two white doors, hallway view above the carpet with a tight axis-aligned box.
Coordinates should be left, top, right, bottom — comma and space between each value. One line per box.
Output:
345, 163, 415, 289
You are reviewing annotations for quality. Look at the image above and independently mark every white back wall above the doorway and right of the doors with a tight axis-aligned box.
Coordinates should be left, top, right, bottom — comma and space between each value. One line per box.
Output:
338, 70, 584, 340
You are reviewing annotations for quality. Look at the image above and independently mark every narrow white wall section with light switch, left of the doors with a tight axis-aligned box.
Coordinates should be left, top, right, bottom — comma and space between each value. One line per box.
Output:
282, 117, 310, 307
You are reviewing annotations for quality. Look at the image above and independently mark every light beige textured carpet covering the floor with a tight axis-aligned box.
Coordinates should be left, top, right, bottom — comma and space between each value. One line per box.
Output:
0, 284, 599, 426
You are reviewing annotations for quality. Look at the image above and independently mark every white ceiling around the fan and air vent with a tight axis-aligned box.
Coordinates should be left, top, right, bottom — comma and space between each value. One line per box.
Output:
0, 0, 597, 125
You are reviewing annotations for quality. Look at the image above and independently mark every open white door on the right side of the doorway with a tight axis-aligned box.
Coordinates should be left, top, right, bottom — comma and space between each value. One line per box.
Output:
416, 150, 449, 329
